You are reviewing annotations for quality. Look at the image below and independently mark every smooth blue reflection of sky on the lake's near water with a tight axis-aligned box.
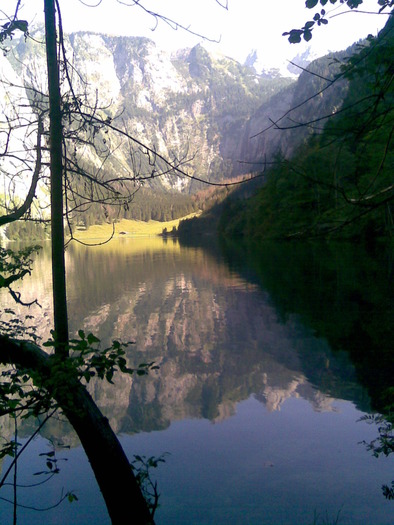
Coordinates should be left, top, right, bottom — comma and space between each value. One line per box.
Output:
0, 398, 393, 525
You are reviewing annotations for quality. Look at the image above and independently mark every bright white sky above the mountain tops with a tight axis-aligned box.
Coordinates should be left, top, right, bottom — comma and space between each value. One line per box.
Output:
0, 0, 387, 66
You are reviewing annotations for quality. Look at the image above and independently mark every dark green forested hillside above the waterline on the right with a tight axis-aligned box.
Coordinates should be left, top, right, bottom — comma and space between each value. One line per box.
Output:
221, 17, 394, 240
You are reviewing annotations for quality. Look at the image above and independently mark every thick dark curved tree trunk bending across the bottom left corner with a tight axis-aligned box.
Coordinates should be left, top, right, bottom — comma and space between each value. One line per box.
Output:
0, 336, 154, 525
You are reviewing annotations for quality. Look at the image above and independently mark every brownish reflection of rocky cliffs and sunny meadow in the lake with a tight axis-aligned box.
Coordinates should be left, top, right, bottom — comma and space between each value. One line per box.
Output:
1, 239, 363, 438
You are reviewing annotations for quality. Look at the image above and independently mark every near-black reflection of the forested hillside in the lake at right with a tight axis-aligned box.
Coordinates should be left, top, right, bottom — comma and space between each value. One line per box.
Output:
220, 238, 394, 418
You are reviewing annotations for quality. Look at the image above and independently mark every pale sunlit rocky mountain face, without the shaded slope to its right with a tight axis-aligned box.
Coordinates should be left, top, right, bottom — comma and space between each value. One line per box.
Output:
3, 31, 292, 193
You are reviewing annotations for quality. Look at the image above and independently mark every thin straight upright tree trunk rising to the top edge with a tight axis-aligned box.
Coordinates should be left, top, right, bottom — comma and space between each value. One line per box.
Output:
44, 0, 68, 354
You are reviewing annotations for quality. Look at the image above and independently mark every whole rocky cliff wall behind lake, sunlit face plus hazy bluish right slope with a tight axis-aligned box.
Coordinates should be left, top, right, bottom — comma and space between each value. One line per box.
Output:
0, 26, 354, 193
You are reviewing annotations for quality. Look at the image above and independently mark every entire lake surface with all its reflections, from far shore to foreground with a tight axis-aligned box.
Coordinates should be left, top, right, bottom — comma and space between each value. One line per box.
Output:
0, 239, 394, 525
